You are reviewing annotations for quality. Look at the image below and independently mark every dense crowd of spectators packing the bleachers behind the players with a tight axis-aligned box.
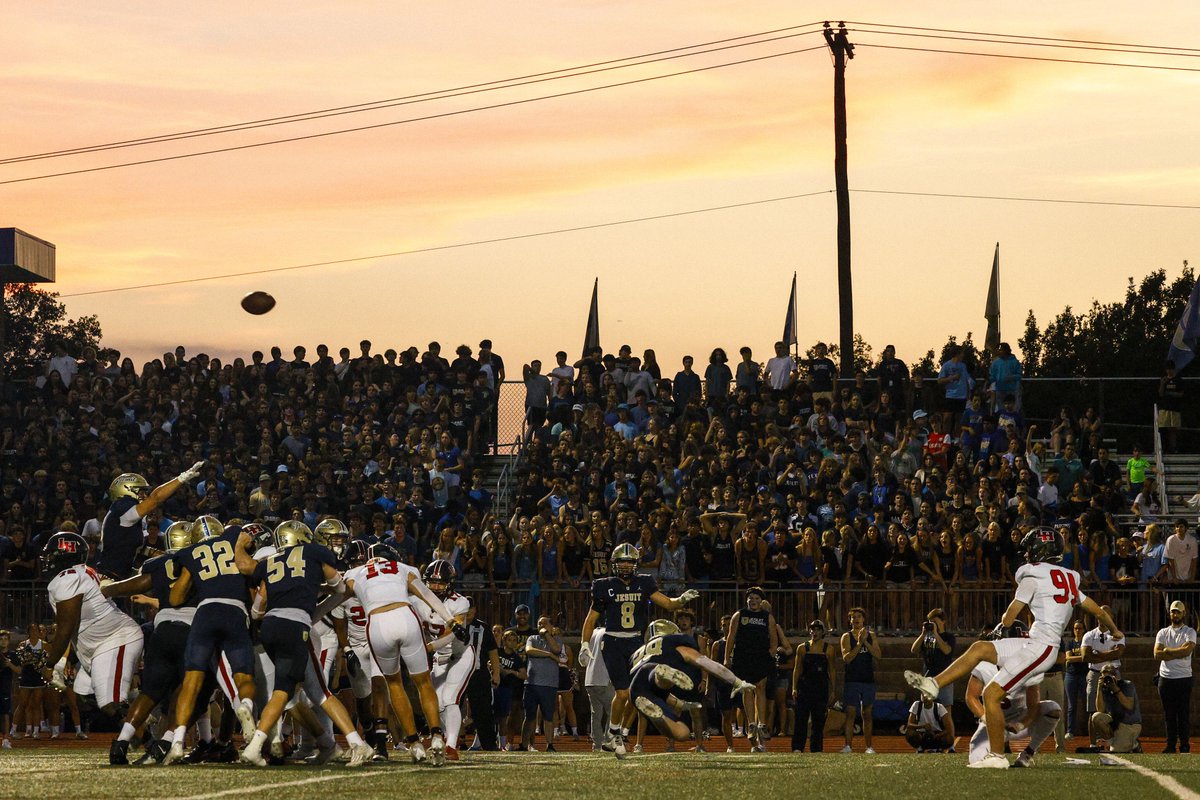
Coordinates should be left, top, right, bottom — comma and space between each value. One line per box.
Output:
0, 341, 1196, 762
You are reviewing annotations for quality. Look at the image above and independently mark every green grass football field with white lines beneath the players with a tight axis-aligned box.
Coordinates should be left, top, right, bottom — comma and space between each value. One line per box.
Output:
0, 747, 1200, 800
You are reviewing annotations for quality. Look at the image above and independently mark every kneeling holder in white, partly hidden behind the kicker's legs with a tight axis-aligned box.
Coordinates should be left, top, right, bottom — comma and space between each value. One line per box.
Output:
965, 622, 1062, 768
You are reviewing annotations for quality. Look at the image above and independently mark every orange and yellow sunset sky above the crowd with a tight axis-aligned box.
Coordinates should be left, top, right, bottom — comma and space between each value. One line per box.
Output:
0, 0, 1200, 377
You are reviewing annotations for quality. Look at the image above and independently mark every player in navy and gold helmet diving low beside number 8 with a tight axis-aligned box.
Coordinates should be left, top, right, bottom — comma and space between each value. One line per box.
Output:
618, 619, 754, 758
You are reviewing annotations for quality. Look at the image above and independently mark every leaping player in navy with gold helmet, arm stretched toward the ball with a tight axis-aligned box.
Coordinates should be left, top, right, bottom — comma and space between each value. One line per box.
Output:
96, 461, 205, 581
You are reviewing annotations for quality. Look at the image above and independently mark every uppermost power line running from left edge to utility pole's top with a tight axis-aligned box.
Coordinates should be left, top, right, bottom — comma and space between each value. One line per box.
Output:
0, 23, 820, 164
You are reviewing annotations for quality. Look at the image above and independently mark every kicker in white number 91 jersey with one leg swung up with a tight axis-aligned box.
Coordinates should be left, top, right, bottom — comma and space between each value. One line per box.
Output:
905, 528, 1124, 769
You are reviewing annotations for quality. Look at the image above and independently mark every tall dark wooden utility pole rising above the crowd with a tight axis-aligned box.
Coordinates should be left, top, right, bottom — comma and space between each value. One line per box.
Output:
824, 23, 854, 378
